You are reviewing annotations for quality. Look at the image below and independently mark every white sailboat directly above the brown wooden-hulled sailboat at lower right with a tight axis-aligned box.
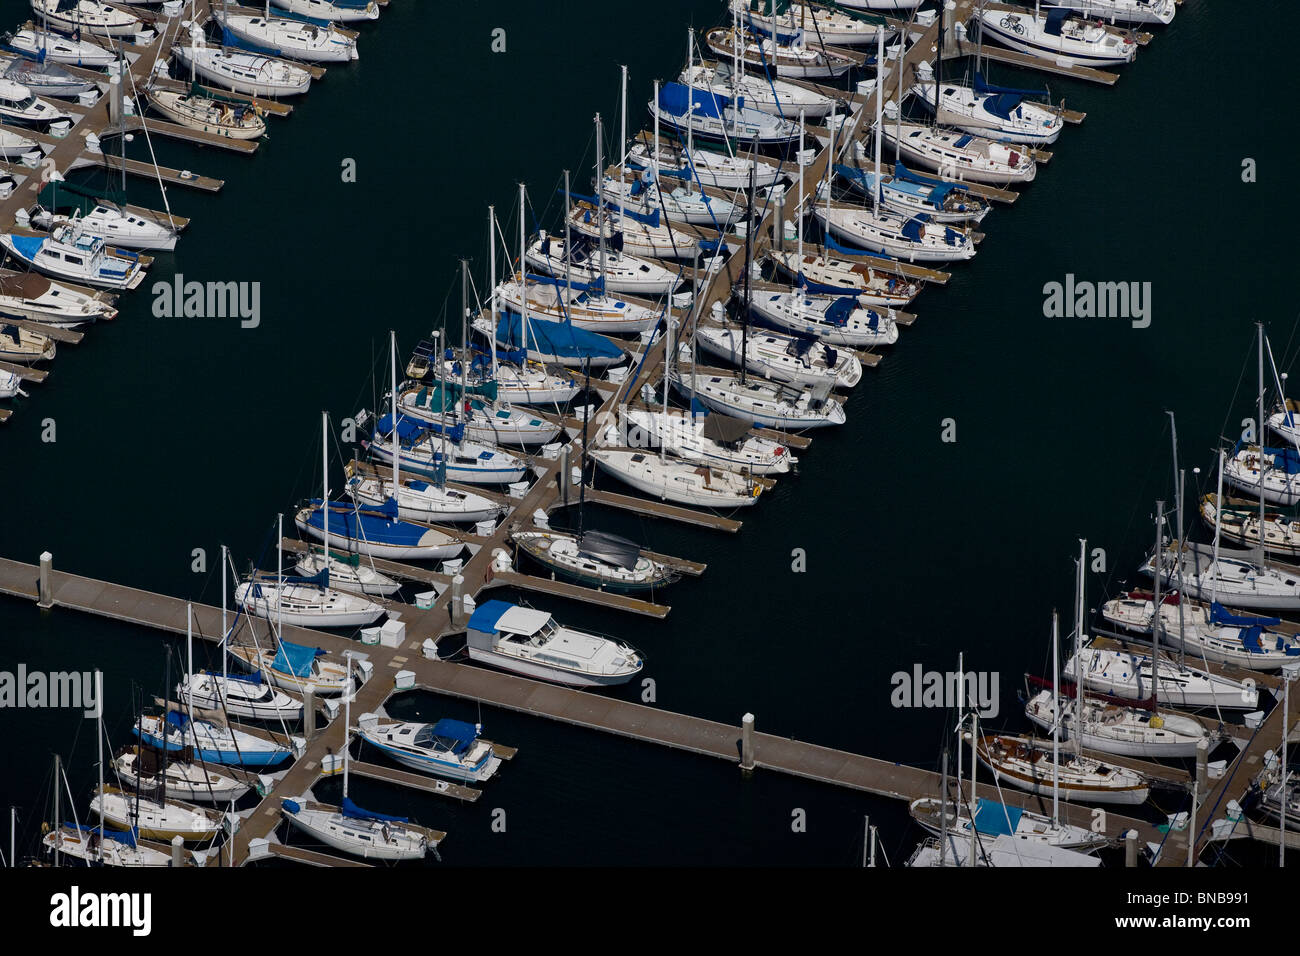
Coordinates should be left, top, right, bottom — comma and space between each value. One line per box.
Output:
1024, 540, 1209, 757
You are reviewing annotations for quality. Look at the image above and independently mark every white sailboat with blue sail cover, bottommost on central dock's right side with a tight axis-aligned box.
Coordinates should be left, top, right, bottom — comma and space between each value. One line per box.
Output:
280, 653, 445, 860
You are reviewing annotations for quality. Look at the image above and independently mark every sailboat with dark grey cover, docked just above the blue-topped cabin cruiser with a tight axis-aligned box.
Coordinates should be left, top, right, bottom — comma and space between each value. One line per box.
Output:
511, 531, 679, 592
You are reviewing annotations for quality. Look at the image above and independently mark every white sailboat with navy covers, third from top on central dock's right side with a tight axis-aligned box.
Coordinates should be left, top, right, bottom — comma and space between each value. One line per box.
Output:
909, 64, 1065, 146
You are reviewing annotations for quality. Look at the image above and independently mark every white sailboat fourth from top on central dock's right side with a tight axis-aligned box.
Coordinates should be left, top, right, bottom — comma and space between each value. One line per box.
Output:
884, 121, 1037, 186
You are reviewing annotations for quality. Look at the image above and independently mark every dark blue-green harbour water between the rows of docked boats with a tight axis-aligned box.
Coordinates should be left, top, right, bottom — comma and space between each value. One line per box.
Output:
0, 0, 1295, 865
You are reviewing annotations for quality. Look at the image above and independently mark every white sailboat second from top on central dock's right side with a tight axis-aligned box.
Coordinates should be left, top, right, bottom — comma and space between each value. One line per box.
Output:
975, 7, 1138, 69
